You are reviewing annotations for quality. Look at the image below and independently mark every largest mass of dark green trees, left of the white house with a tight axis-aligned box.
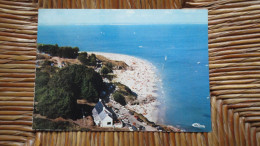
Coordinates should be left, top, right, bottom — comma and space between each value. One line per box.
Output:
35, 64, 105, 119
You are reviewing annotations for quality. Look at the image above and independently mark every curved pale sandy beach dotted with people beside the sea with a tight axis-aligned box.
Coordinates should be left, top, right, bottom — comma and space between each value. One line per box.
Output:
88, 52, 160, 122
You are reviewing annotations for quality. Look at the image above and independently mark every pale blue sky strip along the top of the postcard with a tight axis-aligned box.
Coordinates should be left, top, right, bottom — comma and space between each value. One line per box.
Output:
38, 9, 208, 26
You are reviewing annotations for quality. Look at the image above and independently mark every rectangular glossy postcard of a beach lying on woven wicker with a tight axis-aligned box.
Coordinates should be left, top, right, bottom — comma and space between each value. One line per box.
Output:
33, 9, 211, 132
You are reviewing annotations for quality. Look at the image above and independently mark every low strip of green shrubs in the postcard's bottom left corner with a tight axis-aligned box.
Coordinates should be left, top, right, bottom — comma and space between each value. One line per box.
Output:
33, 118, 76, 130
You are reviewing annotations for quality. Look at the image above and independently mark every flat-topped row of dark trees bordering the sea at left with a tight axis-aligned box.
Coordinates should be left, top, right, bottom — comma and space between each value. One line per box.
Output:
37, 44, 79, 58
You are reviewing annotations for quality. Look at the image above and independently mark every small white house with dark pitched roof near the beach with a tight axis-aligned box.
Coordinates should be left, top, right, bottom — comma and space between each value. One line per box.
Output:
92, 100, 113, 127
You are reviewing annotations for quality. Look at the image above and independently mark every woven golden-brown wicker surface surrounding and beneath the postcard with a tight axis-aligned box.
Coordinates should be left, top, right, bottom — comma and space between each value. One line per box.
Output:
0, 0, 260, 146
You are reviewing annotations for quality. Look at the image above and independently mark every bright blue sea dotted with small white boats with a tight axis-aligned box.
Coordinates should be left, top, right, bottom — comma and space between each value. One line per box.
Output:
38, 24, 211, 132
